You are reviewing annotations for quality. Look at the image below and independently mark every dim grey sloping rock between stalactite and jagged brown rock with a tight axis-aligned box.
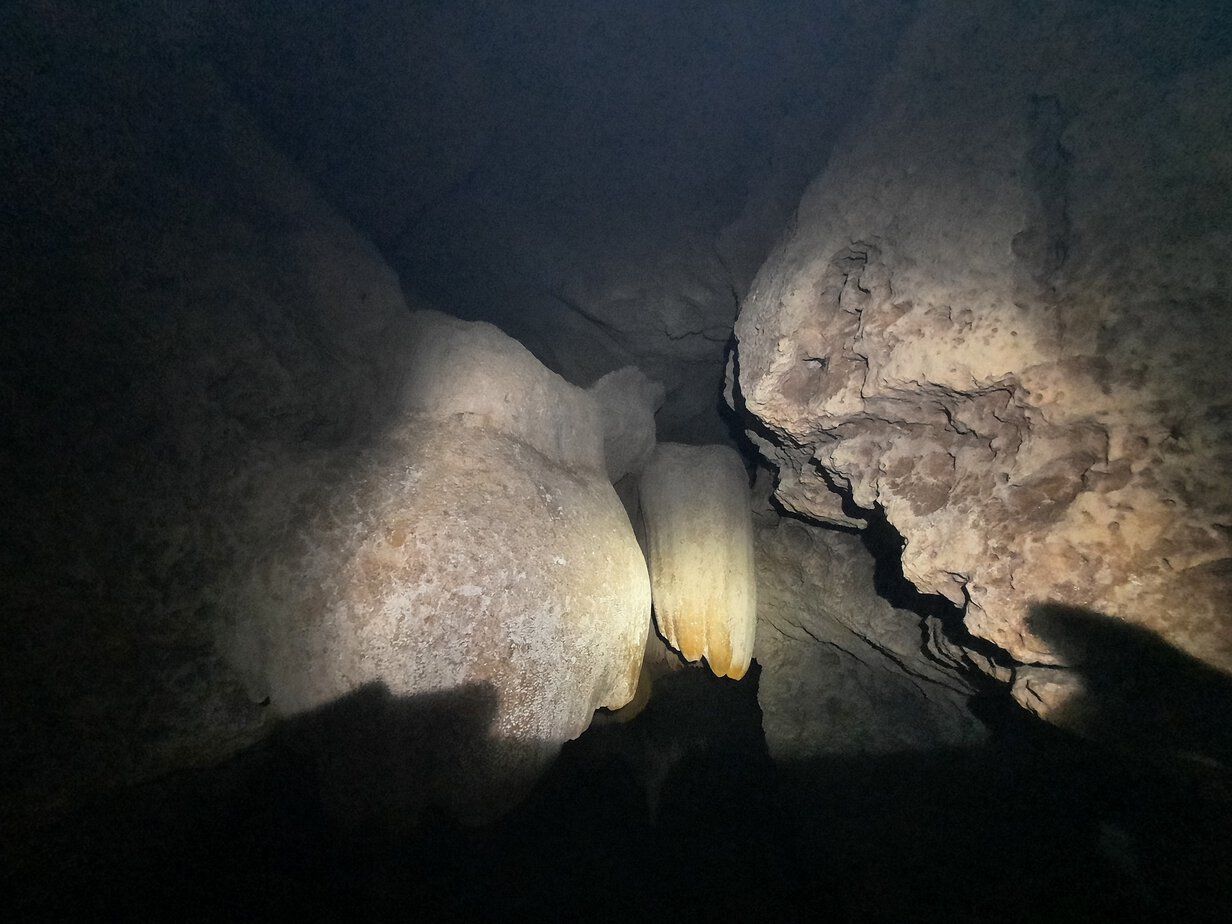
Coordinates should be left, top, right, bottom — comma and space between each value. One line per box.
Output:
755, 519, 983, 760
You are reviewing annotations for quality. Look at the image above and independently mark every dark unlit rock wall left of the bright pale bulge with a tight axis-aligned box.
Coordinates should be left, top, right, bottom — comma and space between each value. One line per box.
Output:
0, 4, 411, 817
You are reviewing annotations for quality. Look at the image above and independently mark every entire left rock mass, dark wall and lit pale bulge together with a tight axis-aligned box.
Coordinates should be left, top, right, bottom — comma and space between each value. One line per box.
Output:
0, 7, 657, 832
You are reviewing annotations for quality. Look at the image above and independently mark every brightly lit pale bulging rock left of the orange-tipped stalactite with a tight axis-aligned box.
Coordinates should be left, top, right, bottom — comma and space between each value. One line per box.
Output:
229, 313, 650, 819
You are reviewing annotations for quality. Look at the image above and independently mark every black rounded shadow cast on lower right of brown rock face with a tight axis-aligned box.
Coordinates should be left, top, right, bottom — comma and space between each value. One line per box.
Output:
1027, 601, 1232, 769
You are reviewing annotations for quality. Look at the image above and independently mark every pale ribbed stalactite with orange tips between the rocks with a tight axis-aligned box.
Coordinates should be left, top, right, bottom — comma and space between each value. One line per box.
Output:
641, 444, 756, 680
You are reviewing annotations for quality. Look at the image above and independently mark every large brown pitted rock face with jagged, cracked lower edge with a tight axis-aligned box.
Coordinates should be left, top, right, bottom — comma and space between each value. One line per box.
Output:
736, 1, 1232, 712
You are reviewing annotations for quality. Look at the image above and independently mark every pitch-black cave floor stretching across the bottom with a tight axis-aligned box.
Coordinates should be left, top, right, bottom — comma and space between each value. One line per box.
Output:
5, 671, 1232, 922
